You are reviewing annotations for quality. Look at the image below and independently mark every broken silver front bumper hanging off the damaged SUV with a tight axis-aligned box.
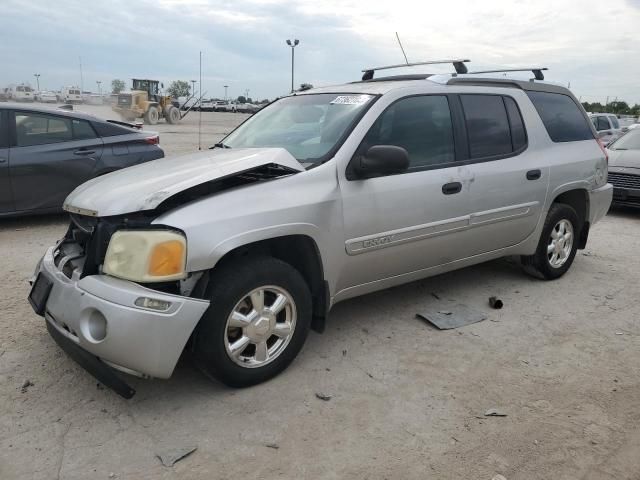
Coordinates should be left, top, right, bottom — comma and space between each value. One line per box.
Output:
33, 248, 209, 392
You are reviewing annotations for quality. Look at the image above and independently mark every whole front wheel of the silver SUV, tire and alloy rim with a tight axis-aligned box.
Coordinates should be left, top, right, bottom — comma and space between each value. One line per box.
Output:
194, 257, 312, 387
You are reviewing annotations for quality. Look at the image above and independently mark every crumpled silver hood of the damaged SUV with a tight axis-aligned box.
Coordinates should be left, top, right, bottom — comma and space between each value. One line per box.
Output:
64, 148, 304, 217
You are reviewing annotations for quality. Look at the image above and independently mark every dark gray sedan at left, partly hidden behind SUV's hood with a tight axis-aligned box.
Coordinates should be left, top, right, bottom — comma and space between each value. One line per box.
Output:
0, 103, 164, 216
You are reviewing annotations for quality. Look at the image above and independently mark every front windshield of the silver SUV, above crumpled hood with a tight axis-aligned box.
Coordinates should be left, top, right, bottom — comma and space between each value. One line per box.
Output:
223, 93, 375, 164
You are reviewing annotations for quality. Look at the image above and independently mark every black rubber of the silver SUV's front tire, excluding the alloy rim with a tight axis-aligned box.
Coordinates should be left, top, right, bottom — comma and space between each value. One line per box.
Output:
194, 256, 312, 387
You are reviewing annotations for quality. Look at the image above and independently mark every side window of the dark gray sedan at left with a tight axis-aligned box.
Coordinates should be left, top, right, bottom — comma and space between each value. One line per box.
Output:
15, 113, 73, 147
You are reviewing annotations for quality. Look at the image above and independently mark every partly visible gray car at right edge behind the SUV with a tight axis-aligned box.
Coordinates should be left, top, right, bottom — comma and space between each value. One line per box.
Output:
607, 128, 640, 207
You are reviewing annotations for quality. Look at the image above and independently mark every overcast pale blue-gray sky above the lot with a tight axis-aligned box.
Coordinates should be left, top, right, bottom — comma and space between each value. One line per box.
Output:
0, 0, 640, 103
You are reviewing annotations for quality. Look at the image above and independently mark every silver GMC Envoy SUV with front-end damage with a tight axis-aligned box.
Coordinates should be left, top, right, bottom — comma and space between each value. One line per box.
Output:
29, 61, 612, 397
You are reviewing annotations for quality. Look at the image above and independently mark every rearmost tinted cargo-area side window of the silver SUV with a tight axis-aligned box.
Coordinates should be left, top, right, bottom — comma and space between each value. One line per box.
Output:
527, 91, 594, 142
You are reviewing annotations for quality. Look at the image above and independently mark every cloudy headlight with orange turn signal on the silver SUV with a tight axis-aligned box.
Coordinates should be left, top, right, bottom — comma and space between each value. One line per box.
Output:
102, 230, 187, 282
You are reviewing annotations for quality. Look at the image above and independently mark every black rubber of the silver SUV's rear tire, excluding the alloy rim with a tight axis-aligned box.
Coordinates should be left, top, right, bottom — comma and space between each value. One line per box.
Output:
521, 203, 582, 280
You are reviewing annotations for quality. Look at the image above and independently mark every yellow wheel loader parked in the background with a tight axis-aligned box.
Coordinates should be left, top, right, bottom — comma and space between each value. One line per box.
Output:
113, 78, 182, 125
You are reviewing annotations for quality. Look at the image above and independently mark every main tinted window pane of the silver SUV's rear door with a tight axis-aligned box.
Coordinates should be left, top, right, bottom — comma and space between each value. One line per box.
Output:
460, 95, 513, 158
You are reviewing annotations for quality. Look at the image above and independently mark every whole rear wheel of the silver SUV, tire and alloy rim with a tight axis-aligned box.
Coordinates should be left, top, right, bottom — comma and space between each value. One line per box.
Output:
521, 203, 581, 280
